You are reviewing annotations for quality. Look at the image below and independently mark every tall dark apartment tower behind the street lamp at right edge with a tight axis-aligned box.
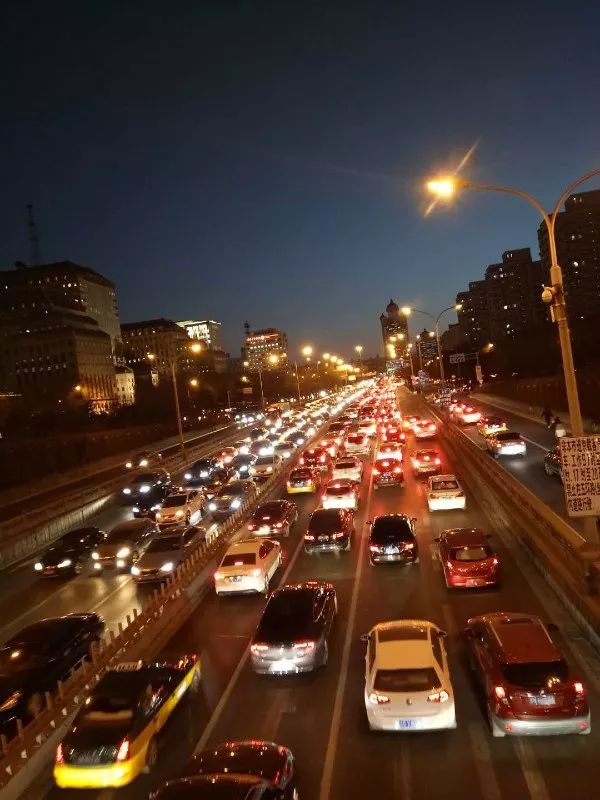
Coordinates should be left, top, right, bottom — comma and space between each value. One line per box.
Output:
538, 189, 600, 325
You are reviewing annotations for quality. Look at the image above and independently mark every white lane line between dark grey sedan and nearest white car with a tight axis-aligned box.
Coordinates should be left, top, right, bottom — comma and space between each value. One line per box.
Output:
319, 472, 373, 800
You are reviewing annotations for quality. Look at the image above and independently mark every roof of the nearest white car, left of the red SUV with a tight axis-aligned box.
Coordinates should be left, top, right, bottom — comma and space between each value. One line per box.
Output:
375, 619, 434, 669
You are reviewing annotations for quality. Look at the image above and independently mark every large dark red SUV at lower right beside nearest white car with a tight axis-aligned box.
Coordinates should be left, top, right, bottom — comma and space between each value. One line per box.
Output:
465, 611, 591, 737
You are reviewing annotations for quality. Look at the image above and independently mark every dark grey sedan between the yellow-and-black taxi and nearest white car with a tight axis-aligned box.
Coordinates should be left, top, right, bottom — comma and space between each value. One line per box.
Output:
250, 581, 337, 675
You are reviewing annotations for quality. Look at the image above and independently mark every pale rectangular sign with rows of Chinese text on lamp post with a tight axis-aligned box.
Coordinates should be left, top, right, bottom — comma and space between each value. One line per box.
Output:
560, 436, 600, 517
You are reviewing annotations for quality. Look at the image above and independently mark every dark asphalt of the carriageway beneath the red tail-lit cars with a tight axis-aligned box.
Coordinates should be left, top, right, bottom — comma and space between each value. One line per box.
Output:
41, 397, 600, 800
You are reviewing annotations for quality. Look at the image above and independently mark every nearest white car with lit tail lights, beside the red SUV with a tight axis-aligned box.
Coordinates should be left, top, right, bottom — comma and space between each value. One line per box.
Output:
363, 619, 456, 733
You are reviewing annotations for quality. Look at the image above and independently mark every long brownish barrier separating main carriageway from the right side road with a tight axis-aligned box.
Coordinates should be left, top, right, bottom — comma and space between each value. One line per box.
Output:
441, 422, 600, 608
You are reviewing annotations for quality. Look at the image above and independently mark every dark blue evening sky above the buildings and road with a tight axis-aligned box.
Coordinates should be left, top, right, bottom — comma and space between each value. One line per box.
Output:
0, 0, 600, 355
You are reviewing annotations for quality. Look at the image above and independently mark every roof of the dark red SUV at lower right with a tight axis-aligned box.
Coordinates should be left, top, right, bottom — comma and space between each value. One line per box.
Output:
480, 611, 562, 664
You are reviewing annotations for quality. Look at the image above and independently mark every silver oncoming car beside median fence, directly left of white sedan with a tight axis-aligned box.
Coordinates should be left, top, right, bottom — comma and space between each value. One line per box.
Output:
131, 524, 209, 583
